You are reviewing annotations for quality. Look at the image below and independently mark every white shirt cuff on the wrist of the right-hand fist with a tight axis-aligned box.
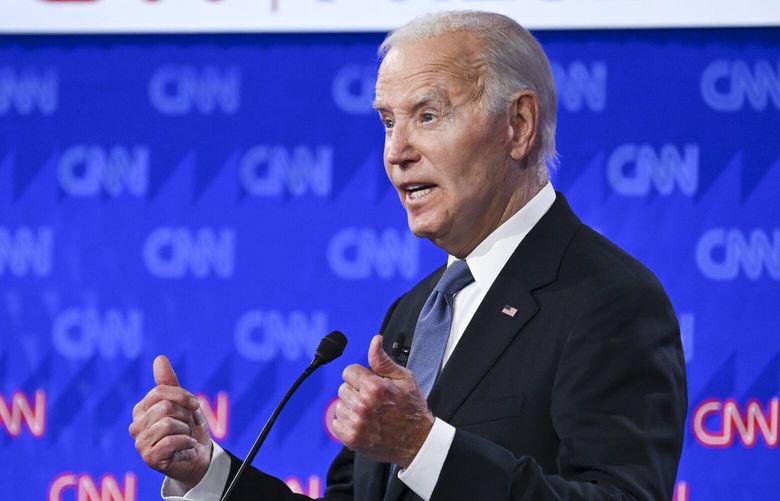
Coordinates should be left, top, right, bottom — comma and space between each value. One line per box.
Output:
398, 418, 455, 501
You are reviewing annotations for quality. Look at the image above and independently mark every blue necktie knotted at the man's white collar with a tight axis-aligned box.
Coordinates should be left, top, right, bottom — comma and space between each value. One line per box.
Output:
406, 260, 474, 398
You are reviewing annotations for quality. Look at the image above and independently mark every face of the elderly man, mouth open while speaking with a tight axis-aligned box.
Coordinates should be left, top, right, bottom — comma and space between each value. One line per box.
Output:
374, 33, 519, 257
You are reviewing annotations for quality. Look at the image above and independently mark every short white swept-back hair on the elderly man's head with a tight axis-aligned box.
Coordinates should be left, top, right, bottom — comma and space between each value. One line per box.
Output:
379, 10, 557, 183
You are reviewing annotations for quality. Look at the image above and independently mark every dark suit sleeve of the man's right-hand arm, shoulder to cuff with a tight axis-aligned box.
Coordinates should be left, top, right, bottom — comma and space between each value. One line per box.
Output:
431, 283, 687, 501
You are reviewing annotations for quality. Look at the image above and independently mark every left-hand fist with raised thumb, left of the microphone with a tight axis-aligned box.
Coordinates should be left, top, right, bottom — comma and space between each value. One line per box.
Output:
130, 355, 212, 489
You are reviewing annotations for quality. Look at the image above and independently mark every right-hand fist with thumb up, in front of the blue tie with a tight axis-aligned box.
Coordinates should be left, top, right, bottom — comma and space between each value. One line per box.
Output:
332, 336, 434, 468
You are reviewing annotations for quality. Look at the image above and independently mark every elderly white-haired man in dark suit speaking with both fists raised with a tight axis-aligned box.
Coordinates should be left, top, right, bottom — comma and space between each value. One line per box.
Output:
130, 8, 687, 501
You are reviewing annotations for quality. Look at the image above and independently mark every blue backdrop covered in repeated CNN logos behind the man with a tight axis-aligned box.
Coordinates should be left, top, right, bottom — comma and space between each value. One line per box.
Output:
0, 29, 780, 501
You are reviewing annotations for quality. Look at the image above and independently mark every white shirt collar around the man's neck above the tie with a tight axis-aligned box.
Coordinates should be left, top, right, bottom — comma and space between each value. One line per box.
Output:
447, 182, 555, 293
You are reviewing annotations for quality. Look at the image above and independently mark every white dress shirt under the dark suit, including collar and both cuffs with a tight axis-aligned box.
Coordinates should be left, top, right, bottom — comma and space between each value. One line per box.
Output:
162, 182, 555, 501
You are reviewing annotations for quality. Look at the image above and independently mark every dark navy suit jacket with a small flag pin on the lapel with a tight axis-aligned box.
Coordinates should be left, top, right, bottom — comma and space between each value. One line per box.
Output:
222, 194, 687, 501
